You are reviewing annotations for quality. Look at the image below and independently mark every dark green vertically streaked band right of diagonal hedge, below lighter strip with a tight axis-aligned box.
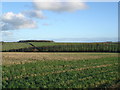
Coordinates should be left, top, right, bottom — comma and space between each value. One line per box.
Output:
33, 44, 118, 52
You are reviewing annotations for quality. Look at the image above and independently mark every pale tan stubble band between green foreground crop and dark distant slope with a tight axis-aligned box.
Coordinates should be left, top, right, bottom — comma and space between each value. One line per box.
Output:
2, 52, 118, 65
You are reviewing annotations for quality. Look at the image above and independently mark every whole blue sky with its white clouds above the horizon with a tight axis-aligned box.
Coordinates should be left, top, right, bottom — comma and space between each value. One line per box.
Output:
0, 2, 118, 42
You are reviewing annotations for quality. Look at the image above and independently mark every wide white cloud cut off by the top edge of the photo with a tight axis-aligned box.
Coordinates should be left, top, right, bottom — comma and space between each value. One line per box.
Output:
33, 0, 87, 12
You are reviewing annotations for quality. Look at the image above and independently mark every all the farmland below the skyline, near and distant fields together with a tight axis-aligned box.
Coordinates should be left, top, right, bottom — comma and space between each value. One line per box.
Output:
2, 42, 120, 88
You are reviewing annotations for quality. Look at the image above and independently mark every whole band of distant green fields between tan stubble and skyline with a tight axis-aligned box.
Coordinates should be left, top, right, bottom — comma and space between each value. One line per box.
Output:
2, 42, 120, 52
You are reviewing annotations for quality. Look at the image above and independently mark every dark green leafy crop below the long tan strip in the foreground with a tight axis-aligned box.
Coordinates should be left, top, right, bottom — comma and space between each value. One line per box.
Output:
3, 64, 119, 88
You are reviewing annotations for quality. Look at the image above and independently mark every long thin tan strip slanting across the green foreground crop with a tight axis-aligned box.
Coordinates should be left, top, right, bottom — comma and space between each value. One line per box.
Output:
3, 64, 117, 80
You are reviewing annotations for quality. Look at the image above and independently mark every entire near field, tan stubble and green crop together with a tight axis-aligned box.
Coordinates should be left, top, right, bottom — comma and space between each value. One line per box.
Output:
2, 52, 120, 88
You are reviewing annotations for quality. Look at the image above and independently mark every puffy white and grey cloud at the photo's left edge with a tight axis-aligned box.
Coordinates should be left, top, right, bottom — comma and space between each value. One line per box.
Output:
0, 12, 36, 30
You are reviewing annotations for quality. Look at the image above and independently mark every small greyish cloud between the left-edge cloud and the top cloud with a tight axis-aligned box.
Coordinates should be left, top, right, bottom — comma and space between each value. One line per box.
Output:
23, 10, 45, 19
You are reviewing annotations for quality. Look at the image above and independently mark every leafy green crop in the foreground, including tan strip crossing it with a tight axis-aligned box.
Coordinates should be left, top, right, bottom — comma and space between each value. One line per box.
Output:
2, 57, 119, 88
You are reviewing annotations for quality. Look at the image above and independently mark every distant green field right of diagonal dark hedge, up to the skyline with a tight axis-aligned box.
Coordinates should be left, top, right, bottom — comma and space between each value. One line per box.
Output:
33, 43, 119, 52
